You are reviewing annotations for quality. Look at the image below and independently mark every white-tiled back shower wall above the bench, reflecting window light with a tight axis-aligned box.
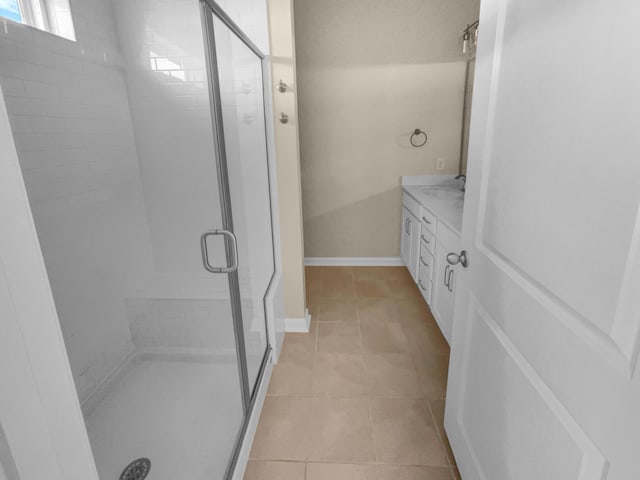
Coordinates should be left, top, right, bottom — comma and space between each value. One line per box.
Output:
113, 0, 226, 278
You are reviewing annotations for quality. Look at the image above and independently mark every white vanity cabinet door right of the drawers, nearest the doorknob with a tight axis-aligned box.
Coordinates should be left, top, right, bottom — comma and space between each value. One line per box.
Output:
431, 239, 455, 344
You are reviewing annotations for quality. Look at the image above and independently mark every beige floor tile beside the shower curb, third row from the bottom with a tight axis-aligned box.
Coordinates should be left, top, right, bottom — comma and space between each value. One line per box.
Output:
267, 353, 314, 395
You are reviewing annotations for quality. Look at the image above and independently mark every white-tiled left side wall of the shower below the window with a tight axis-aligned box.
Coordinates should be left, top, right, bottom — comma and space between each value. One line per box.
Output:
0, 0, 150, 399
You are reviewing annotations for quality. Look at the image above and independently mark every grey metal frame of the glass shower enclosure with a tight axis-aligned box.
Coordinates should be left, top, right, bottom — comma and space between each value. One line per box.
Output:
200, 0, 277, 480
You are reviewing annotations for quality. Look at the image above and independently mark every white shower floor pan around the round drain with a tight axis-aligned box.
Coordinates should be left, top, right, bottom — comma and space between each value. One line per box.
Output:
86, 359, 242, 480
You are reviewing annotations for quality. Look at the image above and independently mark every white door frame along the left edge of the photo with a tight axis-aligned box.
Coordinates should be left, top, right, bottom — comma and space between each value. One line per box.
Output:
0, 88, 98, 480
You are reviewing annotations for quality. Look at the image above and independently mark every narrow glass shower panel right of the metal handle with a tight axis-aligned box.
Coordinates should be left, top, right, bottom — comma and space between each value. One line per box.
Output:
208, 7, 274, 398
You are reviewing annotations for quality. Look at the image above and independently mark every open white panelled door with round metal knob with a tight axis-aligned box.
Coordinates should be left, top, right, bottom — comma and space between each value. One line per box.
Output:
445, 0, 640, 480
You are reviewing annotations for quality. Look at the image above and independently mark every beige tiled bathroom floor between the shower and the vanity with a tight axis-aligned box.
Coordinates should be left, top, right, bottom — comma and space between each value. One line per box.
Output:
244, 267, 460, 480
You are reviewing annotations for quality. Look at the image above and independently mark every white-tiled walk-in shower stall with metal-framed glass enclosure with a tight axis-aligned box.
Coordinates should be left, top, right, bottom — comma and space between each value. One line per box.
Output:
0, 0, 276, 480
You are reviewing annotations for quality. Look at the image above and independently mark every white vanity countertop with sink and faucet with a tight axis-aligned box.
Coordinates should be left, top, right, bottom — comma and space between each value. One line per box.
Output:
402, 175, 464, 235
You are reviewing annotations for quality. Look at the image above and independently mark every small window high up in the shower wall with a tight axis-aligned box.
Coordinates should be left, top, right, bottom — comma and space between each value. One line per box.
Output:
0, 0, 76, 41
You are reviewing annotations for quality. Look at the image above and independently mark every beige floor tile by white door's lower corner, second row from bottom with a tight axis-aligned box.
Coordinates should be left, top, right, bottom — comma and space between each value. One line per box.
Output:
370, 398, 448, 466
